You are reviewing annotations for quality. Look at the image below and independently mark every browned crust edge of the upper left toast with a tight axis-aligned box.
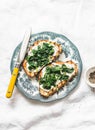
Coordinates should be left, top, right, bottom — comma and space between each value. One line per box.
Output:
22, 40, 62, 77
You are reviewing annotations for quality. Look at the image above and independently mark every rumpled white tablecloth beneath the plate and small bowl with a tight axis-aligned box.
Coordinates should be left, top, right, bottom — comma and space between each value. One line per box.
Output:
0, 0, 95, 130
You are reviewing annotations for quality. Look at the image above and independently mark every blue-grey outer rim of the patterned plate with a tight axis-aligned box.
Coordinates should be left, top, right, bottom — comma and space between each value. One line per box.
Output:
10, 31, 83, 103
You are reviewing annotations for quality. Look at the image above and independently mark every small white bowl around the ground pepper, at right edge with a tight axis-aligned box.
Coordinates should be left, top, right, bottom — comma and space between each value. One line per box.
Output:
86, 66, 95, 88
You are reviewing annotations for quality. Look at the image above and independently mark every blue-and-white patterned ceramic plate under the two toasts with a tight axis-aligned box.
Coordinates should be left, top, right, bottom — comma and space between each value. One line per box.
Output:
10, 32, 82, 102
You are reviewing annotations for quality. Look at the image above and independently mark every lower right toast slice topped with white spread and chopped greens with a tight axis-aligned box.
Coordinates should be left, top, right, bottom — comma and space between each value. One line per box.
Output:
39, 60, 78, 97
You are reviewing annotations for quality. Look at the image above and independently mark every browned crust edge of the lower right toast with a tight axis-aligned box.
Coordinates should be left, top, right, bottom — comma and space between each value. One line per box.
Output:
39, 60, 78, 98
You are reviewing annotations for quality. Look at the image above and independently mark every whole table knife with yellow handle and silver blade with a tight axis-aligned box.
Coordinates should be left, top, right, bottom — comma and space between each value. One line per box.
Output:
6, 29, 31, 98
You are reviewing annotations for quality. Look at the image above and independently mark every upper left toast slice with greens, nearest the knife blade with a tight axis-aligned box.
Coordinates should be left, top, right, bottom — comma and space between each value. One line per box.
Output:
22, 40, 62, 77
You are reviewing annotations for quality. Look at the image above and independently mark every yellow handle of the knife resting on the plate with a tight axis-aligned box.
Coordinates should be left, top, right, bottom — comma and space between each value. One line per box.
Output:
6, 67, 19, 98
